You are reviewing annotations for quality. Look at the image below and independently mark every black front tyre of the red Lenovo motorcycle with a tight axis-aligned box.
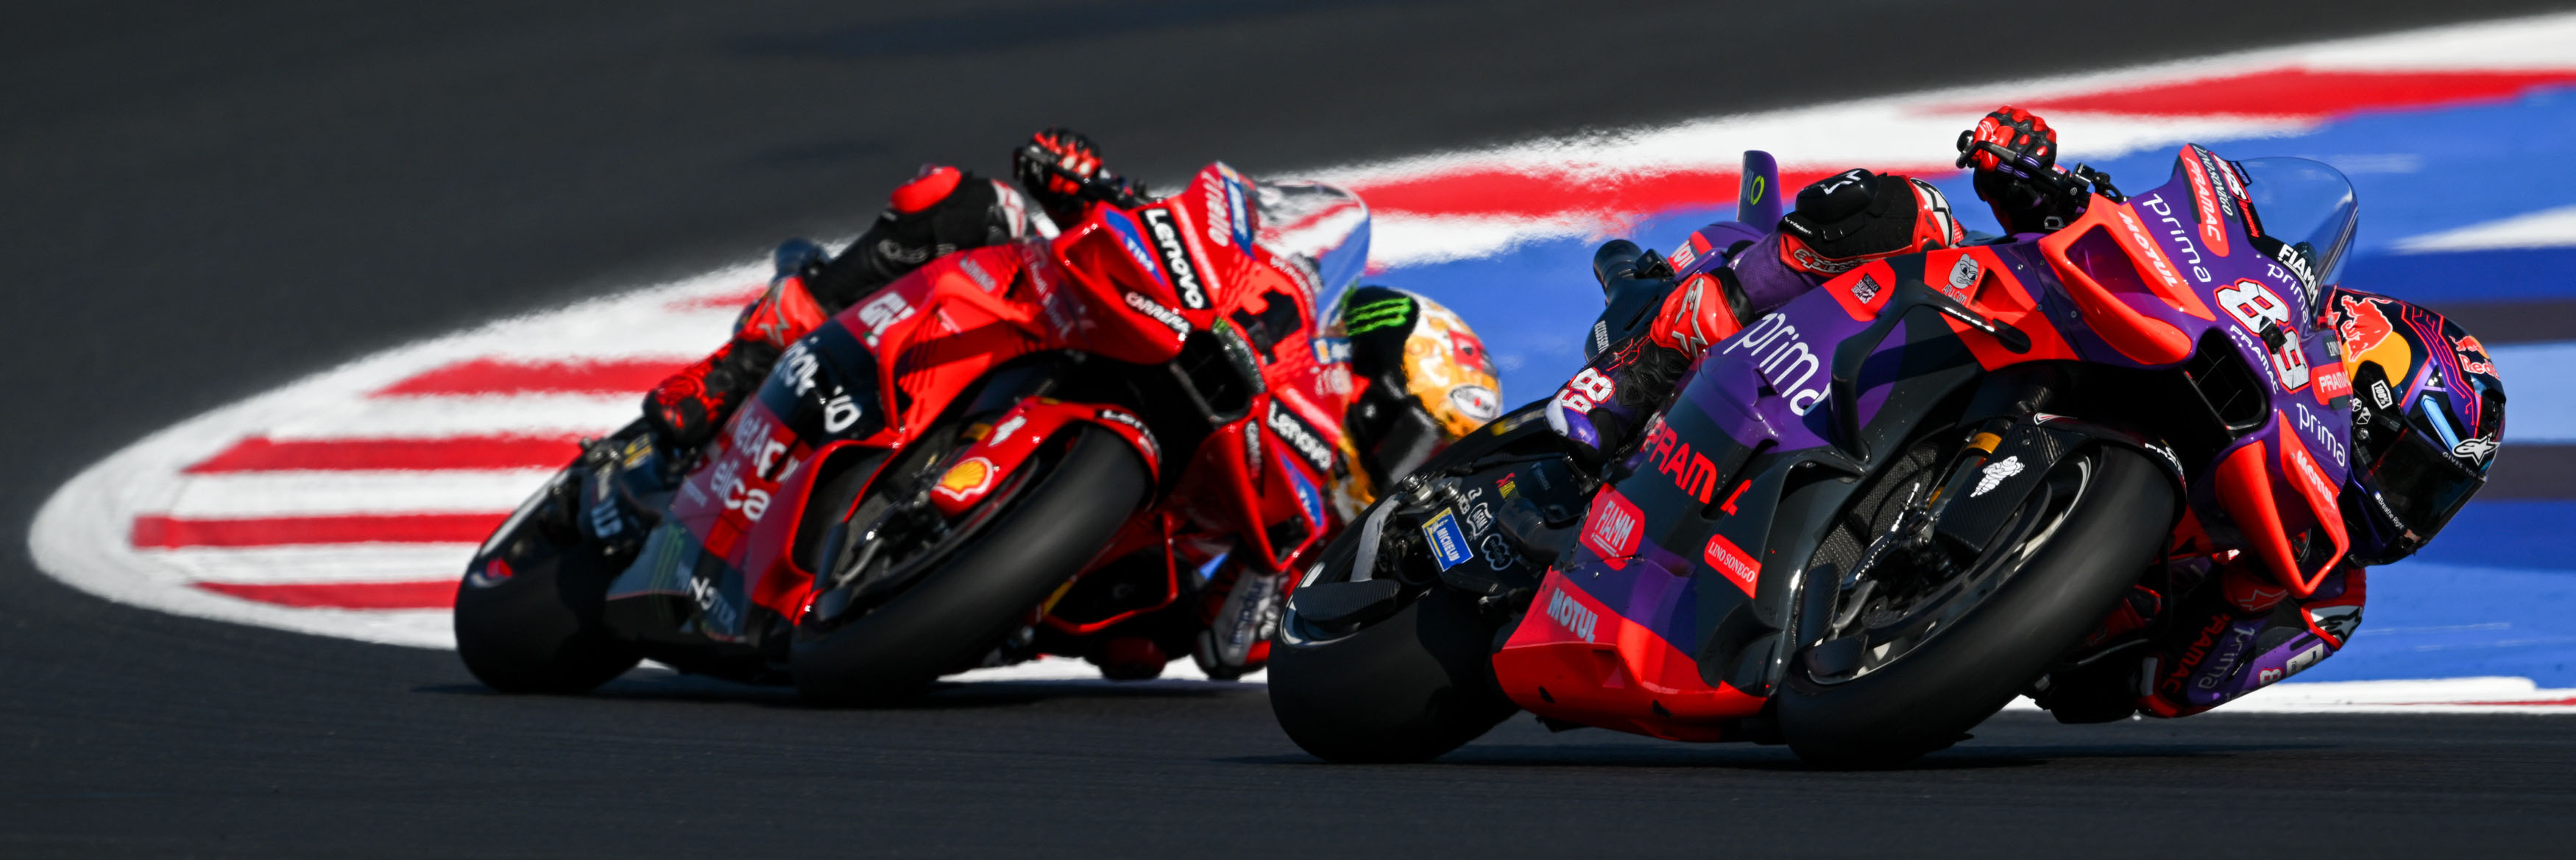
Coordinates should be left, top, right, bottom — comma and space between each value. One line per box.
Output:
791, 425, 1154, 705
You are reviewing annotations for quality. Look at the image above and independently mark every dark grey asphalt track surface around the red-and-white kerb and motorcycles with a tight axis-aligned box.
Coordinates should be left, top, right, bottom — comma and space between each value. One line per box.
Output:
0, 0, 2576, 858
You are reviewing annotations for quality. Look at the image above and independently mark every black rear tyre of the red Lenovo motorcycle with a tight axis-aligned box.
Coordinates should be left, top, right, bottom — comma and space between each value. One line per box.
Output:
456, 510, 644, 693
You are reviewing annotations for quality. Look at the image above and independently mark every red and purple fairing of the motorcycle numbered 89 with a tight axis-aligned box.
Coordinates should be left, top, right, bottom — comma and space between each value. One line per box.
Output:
1494, 147, 2349, 736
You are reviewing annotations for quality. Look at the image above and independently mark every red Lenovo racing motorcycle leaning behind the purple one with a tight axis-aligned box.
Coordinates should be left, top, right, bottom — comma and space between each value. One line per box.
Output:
456, 165, 1368, 703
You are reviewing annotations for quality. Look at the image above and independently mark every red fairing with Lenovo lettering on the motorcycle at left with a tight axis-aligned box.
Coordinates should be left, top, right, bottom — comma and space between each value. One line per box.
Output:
592, 165, 1368, 646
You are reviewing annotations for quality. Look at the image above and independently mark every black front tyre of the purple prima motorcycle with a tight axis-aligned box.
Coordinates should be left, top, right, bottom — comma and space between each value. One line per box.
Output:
1780, 445, 2177, 767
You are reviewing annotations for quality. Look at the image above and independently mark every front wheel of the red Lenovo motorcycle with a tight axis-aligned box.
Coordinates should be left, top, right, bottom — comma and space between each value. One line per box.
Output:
791, 425, 1154, 705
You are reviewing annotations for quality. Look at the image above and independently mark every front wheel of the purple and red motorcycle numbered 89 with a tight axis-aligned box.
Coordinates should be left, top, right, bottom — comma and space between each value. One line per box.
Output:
1780, 445, 2177, 767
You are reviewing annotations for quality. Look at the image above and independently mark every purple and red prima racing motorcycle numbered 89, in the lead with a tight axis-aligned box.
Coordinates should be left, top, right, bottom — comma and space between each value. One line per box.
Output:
1270, 147, 2357, 765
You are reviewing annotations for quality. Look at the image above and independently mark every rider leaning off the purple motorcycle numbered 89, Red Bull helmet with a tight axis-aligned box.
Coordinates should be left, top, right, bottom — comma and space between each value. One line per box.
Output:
1549, 105, 2504, 724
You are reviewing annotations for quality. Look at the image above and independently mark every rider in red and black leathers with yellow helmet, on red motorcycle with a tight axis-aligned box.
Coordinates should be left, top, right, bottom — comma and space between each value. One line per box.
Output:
644, 129, 1499, 680
